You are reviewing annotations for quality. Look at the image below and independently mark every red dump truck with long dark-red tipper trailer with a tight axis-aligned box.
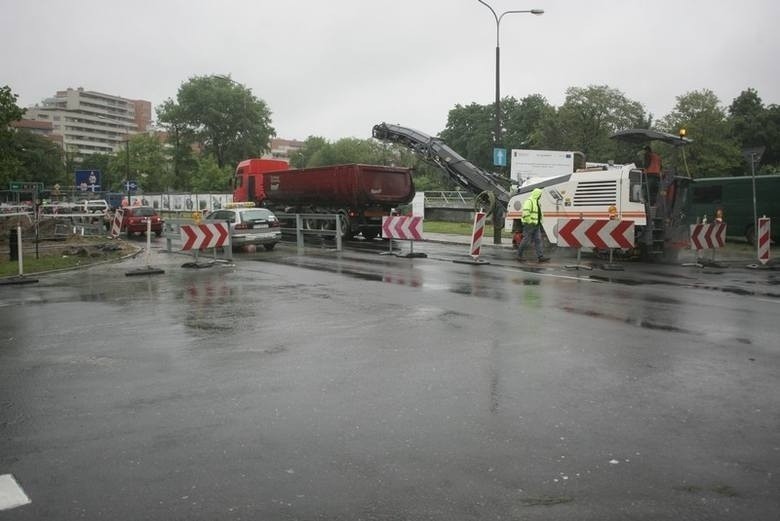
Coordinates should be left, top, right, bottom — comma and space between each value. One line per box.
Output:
233, 159, 414, 239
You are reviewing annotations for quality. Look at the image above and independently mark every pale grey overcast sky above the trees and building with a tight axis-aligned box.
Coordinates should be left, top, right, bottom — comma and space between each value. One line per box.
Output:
0, 0, 780, 140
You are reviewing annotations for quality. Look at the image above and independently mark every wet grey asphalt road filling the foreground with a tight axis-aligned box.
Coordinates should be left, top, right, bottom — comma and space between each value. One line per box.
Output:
0, 238, 780, 521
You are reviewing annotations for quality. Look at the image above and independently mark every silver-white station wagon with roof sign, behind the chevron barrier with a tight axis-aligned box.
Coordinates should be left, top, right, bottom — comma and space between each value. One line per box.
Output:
205, 208, 282, 251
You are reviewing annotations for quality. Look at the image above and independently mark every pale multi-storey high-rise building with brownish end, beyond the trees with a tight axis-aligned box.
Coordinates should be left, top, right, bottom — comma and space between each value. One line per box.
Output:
24, 87, 152, 157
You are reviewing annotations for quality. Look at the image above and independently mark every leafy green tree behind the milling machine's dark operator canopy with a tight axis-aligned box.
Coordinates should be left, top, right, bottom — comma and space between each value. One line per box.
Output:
661, 89, 742, 178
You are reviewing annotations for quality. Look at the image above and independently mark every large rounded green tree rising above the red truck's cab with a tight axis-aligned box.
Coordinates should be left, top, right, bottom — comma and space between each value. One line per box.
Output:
159, 75, 276, 168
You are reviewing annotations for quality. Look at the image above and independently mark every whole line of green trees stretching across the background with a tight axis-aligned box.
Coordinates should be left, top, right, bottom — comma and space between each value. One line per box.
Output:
0, 79, 780, 197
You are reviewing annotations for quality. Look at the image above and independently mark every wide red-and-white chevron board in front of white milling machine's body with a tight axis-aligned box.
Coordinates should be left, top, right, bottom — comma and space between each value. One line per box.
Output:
558, 219, 634, 249
